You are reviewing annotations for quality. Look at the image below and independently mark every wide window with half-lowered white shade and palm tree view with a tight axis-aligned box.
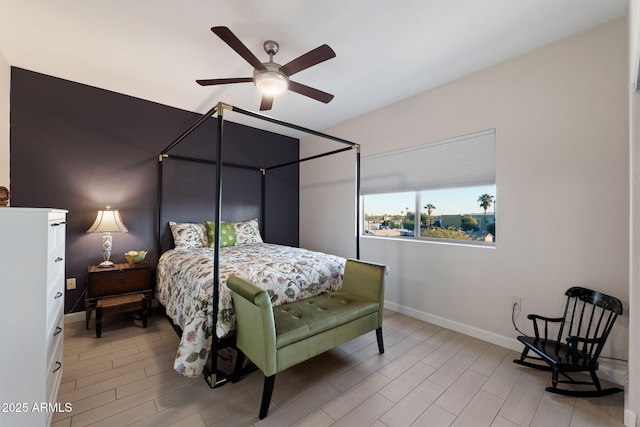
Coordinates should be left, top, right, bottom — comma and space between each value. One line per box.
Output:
361, 129, 496, 245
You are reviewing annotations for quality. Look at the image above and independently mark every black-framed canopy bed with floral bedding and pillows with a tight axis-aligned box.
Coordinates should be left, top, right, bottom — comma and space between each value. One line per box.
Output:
156, 103, 360, 387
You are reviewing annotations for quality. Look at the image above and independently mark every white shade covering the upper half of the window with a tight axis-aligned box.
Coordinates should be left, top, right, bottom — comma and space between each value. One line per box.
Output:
360, 129, 496, 195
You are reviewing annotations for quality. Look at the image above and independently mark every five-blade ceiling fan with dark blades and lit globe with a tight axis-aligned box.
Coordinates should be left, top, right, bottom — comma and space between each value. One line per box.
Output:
196, 27, 336, 111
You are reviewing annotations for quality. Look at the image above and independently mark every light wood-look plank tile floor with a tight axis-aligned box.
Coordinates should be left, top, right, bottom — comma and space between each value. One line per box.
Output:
54, 311, 624, 427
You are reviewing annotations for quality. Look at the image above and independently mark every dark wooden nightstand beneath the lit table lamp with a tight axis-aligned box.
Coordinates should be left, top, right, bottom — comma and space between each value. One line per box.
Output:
84, 264, 153, 329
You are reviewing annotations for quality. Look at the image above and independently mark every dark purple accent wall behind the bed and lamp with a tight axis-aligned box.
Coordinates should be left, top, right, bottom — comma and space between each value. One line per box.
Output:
10, 67, 299, 312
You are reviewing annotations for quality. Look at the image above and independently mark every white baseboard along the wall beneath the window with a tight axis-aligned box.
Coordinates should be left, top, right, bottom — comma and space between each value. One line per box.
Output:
384, 301, 627, 385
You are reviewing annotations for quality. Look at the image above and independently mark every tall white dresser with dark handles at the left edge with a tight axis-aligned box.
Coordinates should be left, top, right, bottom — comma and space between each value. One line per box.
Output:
0, 208, 67, 427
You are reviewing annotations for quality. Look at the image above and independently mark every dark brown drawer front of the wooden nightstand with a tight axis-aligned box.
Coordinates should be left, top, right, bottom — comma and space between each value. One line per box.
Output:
87, 267, 151, 298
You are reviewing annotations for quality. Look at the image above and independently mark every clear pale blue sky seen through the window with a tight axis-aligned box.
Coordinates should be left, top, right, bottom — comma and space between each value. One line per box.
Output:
364, 185, 497, 216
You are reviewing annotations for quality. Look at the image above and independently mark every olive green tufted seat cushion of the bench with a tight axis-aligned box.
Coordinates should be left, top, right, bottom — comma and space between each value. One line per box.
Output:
273, 291, 379, 348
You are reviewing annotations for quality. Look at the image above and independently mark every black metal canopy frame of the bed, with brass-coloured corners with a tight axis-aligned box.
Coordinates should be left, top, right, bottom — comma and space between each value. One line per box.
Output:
157, 102, 360, 388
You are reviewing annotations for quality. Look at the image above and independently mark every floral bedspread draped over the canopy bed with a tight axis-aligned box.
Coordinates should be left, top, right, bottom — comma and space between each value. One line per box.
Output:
156, 243, 346, 377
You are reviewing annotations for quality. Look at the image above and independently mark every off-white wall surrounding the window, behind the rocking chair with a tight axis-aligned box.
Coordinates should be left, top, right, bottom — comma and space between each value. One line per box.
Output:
300, 19, 629, 381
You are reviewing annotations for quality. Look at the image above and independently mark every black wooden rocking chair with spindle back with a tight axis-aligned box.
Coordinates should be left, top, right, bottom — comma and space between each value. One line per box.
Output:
513, 287, 623, 397
